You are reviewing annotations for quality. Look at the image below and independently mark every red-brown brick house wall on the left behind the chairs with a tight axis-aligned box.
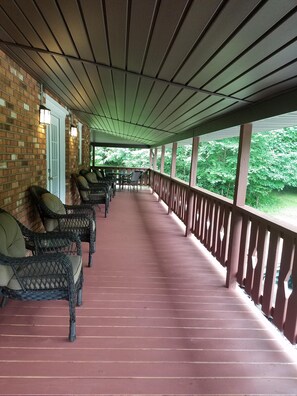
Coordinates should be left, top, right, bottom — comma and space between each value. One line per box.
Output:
0, 51, 90, 229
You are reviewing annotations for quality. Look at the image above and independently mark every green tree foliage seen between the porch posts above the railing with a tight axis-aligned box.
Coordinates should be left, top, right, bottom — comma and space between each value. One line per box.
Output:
95, 127, 297, 207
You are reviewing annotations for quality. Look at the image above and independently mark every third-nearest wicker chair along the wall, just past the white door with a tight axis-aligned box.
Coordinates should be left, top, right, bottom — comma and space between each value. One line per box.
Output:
72, 174, 109, 217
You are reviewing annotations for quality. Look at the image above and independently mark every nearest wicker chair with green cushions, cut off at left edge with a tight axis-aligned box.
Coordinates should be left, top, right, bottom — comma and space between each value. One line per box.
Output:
0, 209, 83, 341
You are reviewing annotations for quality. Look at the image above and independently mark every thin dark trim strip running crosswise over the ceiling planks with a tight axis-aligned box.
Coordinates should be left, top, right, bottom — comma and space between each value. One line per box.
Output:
0, 40, 252, 103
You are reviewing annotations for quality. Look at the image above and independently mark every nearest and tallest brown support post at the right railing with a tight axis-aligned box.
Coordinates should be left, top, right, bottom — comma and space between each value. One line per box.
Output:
226, 124, 252, 288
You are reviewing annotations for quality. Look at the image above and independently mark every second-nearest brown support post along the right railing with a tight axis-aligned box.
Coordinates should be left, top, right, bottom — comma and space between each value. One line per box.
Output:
185, 136, 200, 236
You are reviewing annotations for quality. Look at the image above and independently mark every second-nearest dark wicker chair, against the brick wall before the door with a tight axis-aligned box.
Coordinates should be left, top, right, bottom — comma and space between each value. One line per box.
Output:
29, 186, 96, 267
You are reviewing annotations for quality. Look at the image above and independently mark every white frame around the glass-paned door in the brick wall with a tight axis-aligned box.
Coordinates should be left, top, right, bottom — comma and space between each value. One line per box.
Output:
45, 95, 68, 202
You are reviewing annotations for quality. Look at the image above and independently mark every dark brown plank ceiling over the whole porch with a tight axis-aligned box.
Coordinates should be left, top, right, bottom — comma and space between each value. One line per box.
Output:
0, 0, 297, 146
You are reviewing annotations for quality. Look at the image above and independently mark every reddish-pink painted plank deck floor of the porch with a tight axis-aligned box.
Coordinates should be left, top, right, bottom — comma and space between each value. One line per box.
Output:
0, 190, 297, 396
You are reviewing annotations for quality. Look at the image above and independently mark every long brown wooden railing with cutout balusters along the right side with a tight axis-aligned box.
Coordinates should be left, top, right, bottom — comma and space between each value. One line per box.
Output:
149, 170, 297, 344
